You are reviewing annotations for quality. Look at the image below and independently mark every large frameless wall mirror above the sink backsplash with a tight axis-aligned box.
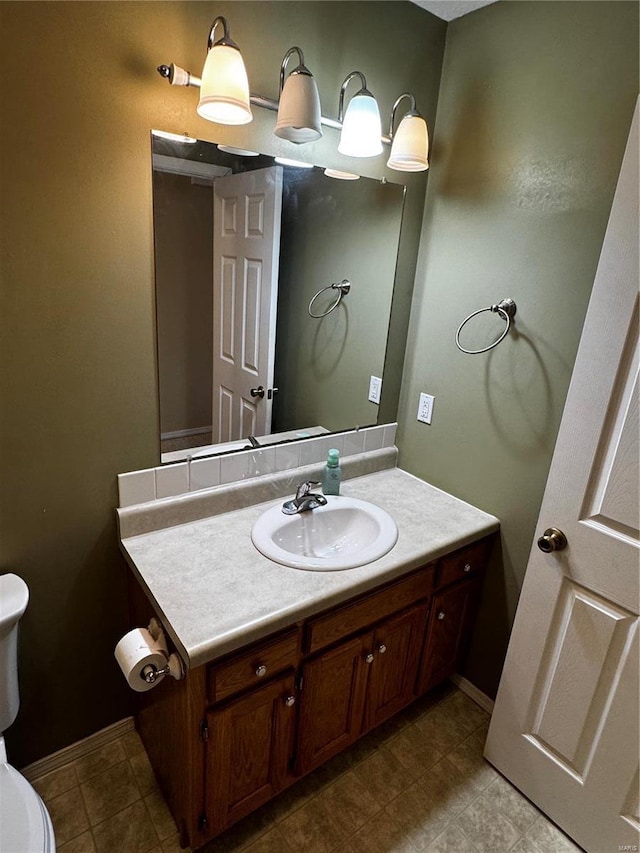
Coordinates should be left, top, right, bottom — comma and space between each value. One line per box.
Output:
151, 131, 405, 463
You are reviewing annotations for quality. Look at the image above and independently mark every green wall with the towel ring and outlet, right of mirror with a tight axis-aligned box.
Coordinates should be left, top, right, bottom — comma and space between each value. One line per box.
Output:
399, 0, 638, 694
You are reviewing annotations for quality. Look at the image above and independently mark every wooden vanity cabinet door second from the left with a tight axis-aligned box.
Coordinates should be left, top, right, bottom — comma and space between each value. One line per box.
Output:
297, 633, 373, 774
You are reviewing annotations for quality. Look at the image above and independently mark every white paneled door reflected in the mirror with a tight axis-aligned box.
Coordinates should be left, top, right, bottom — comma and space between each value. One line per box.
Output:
212, 166, 282, 443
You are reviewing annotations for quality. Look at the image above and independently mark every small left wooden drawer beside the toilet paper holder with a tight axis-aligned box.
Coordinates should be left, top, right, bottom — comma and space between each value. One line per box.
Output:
207, 628, 299, 702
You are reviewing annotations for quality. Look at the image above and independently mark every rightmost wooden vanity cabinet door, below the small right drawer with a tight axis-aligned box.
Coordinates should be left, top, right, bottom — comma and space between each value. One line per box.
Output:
418, 580, 480, 693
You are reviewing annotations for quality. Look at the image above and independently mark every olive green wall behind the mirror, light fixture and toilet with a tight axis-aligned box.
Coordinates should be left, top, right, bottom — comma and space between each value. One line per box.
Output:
0, 2, 446, 766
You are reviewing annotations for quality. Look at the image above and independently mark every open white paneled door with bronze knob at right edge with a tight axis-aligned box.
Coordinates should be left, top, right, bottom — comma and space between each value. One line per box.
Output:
485, 101, 640, 853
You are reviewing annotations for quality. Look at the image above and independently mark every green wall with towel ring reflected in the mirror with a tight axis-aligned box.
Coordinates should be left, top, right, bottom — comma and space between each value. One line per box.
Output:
274, 167, 404, 432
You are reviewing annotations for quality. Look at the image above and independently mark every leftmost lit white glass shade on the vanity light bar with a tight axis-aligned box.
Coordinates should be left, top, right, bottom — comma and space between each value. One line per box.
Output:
197, 44, 253, 124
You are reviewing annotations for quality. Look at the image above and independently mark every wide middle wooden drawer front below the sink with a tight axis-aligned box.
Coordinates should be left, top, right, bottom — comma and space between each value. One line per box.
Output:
305, 566, 435, 653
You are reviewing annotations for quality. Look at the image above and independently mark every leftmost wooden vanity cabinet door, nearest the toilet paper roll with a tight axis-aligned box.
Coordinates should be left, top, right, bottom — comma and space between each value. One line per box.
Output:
205, 675, 295, 833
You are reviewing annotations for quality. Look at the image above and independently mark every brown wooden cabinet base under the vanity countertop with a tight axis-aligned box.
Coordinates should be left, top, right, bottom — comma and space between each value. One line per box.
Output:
131, 540, 490, 848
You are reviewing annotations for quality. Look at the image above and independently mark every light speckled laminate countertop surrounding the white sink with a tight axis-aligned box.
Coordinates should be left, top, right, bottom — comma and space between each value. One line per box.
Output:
121, 468, 499, 667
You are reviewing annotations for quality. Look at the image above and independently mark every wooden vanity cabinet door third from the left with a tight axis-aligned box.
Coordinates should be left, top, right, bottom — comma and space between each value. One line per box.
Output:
364, 604, 428, 731
